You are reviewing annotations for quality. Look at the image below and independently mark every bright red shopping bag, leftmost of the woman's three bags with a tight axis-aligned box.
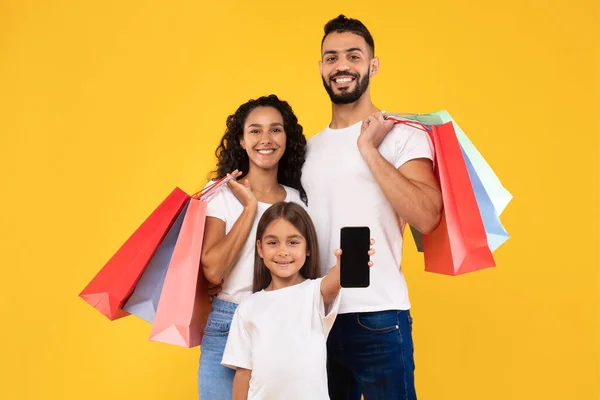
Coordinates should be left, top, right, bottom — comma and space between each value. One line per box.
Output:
79, 188, 190, 320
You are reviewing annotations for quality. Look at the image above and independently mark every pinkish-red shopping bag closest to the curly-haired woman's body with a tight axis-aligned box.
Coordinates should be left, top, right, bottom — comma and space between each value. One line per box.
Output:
150, 178, 230, 348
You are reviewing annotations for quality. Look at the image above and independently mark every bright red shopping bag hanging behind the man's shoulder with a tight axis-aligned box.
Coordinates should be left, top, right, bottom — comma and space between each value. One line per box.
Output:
395, 120, 496, 275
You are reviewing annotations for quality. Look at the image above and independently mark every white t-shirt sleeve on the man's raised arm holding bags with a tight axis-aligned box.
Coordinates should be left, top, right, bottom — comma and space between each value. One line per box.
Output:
394, 126, 435, 168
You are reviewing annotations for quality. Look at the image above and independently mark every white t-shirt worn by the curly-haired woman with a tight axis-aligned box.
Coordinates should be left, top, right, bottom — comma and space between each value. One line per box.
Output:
206, 182, 306, 304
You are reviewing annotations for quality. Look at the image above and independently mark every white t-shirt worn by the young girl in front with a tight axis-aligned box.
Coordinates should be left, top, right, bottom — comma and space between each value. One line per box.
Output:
221, 278, 345, 400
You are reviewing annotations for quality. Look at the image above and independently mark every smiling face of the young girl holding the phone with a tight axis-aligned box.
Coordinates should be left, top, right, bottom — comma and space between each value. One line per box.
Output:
256, 218, 306, 282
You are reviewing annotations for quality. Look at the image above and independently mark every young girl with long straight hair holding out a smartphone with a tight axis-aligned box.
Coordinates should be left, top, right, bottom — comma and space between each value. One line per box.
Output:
222, 202, 374, 400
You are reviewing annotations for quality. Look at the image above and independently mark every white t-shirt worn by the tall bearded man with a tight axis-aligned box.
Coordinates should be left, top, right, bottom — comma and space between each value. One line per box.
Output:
302, 122, 434, 314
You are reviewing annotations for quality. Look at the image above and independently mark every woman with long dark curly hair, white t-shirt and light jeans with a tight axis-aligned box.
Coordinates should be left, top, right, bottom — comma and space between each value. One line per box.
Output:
198, 95, 306, 400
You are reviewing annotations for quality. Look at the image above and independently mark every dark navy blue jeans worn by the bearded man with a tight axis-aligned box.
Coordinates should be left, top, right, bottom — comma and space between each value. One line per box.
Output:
327, 310, 417, 400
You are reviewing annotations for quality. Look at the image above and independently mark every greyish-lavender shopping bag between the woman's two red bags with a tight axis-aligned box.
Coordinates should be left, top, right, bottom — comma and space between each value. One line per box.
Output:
123, 202, 189, 323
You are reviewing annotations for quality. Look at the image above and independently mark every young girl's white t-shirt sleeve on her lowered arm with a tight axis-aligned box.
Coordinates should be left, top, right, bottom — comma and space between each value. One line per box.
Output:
221, 306, 252, 369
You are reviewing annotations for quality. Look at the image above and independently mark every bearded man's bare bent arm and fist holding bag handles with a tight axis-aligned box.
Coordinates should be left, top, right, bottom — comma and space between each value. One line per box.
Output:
358, 113, 442, 234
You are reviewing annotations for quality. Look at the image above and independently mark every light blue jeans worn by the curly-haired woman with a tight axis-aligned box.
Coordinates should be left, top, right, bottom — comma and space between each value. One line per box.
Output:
198, 299, 237, 400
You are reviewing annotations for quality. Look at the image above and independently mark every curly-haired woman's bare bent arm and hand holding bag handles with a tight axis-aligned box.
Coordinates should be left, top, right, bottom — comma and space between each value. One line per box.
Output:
201, 175, 257, 285
